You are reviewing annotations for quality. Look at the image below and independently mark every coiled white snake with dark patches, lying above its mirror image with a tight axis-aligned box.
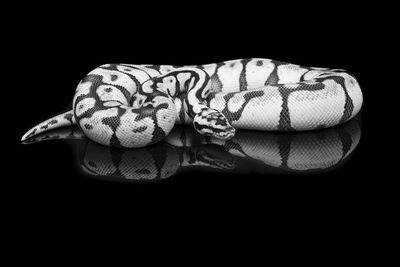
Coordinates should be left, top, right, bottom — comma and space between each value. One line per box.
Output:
22, 58, 363, 148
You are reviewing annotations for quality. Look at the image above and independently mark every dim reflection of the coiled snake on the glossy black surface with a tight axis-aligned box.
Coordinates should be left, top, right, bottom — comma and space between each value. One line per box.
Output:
26, 119, 361, 181
